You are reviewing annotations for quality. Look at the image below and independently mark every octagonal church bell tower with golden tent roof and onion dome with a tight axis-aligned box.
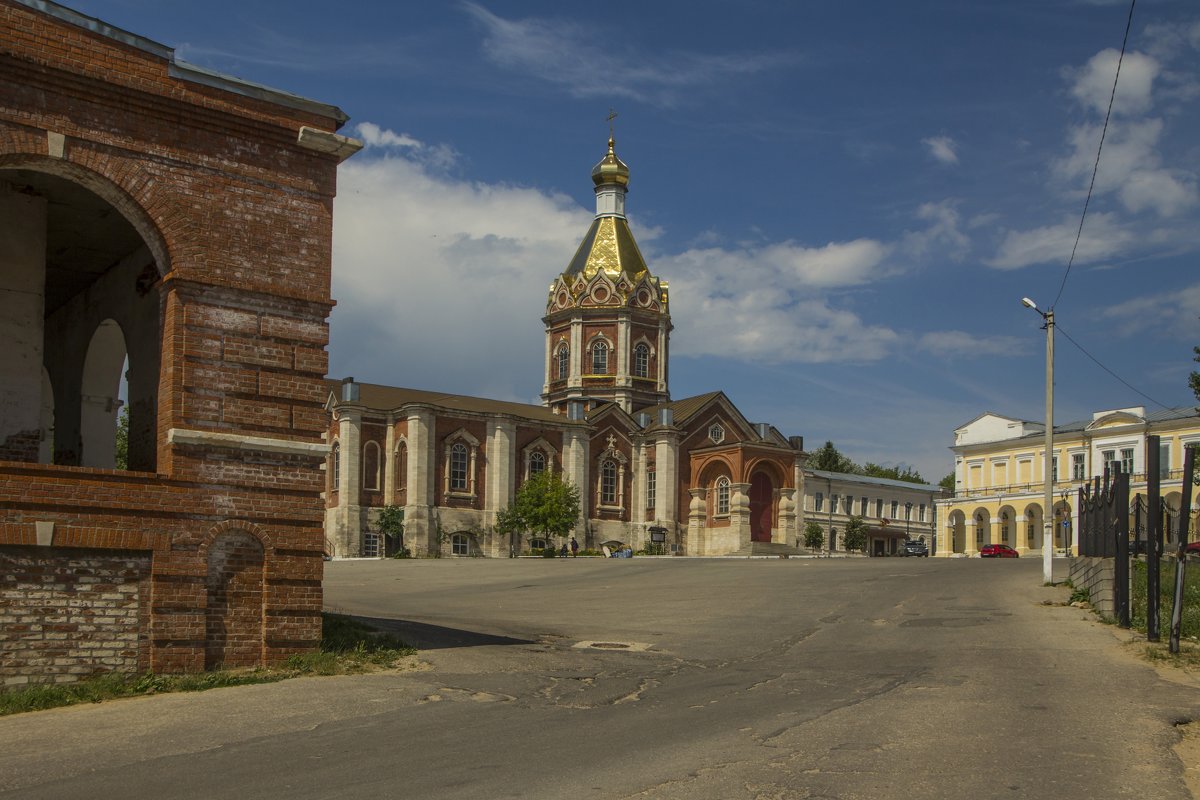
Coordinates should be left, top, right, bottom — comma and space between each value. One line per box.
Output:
541, 134, 671, 414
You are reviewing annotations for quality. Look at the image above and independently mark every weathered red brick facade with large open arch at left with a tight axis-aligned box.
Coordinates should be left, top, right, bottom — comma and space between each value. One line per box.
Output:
0, 0, 354, 680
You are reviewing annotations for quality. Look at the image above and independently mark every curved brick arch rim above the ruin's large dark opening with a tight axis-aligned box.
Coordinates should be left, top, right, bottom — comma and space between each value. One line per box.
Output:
0, 151, 171, 276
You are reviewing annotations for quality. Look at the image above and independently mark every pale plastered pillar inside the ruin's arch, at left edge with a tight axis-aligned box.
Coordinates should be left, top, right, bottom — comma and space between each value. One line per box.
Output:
0, 184, 46, 462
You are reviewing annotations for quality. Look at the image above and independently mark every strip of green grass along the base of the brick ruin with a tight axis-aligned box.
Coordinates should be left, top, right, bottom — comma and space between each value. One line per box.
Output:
0, 614, 416, 716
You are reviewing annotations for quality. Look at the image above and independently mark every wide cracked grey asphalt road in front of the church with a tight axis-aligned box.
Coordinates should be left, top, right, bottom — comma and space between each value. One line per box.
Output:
0, 559, 1200, 800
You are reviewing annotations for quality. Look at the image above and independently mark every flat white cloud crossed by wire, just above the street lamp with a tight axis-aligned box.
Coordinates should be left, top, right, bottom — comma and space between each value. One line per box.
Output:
986, 213, 1135, 270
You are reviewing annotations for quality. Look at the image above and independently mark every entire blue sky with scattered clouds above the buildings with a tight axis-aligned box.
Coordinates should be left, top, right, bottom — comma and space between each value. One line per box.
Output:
72, 0, 1200, 481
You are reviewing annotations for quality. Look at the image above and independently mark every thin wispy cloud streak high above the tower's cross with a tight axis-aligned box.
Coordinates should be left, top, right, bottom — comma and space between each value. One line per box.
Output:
463, 2, 794, 106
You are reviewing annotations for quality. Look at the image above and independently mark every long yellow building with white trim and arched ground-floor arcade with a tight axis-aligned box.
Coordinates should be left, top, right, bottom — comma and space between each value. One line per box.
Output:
937, 407, 1200, 557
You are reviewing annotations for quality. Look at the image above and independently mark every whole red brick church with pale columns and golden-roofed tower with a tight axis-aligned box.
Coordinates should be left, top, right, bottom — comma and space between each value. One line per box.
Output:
325, 138, 806, 557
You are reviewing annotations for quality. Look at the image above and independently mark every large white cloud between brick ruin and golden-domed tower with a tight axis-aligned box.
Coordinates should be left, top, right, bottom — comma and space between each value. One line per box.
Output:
331, 143, 592, 401
